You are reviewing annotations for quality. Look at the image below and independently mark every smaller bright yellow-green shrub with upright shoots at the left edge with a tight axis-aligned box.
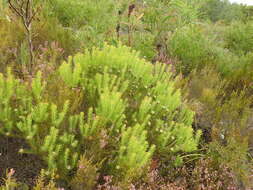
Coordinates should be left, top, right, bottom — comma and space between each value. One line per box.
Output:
0, 69, 82, 178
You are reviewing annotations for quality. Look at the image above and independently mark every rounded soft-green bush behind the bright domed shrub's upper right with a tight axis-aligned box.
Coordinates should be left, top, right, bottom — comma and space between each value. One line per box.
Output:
168, 26, 212, 74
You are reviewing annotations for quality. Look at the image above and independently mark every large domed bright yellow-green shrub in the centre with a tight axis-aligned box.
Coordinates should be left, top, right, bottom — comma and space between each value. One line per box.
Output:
59, 45, 201, 183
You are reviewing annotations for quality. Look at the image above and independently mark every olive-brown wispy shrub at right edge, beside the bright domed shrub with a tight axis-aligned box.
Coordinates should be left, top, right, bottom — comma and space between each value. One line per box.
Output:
183, 67, 252, 189
